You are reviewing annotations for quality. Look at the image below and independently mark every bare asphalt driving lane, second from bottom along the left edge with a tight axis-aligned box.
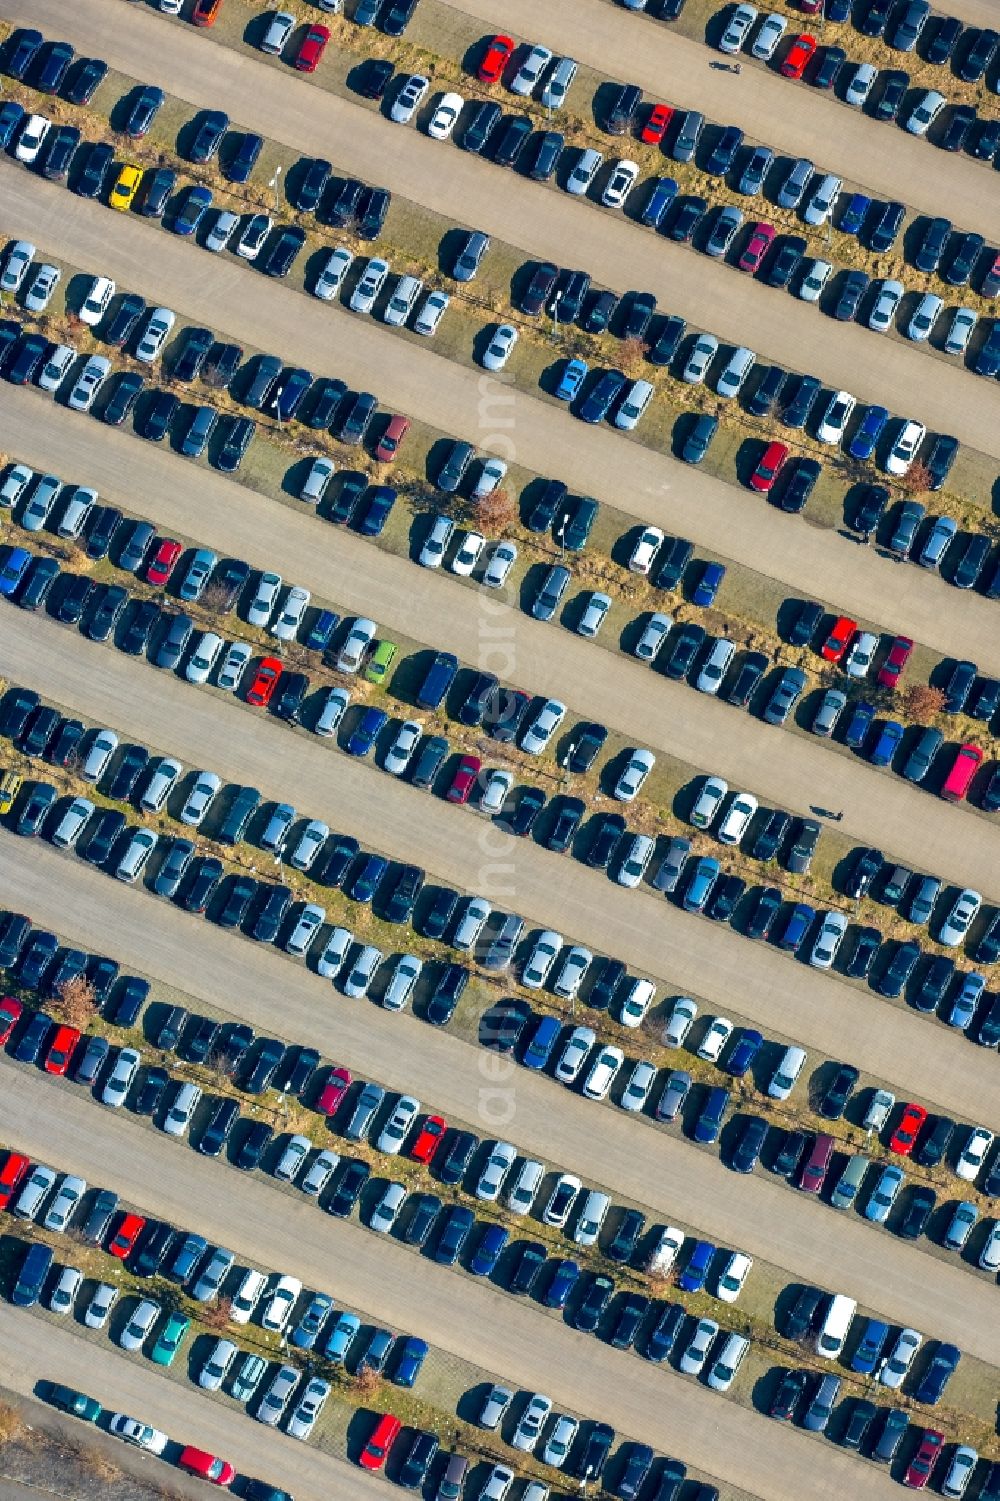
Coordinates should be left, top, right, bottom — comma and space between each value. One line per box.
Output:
0, 1066, 896, 1501
